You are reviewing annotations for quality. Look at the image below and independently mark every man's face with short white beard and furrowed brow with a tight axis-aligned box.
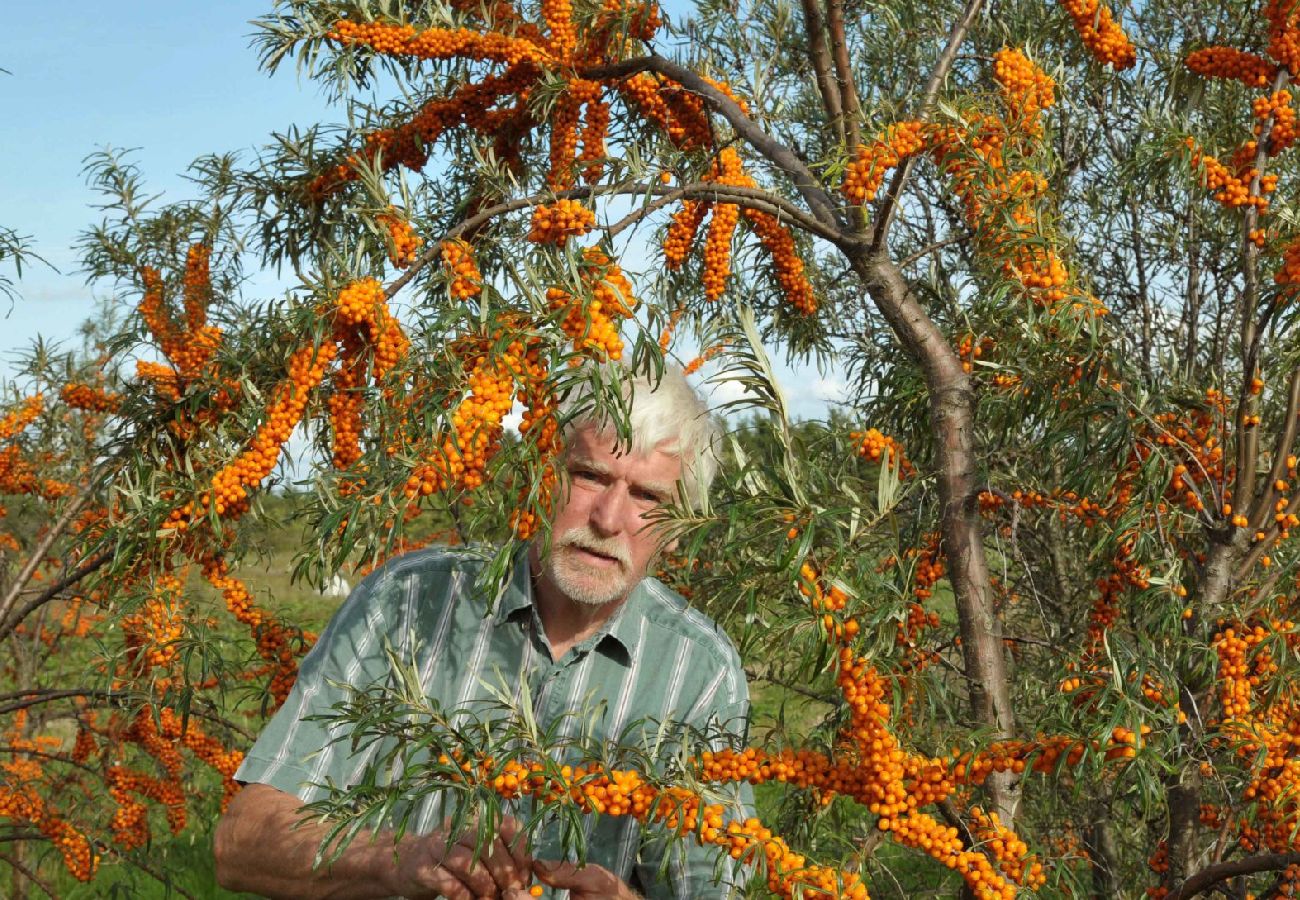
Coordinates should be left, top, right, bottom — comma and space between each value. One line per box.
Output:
541, 427, 681, 606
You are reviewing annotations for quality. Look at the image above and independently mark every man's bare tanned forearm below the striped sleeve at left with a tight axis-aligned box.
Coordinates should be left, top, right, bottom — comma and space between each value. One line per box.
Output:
215, 784, 394, 900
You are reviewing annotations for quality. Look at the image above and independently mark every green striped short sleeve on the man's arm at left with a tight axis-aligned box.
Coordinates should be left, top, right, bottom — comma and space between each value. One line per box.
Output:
235, 570, 394, 802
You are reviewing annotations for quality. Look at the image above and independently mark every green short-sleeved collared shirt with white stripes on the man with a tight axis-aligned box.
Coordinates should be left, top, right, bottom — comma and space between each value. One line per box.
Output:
235, 549, 753, 897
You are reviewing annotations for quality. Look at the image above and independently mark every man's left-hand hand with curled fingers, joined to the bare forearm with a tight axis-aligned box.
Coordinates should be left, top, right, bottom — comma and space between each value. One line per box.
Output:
389, 818, 533, 900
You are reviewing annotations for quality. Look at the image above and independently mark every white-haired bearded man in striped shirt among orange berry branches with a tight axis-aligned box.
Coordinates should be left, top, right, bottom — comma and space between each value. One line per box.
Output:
216, 369, 751, 900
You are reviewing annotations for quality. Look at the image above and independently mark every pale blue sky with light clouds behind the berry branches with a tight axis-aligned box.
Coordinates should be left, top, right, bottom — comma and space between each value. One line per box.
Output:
0, 0, 837, 416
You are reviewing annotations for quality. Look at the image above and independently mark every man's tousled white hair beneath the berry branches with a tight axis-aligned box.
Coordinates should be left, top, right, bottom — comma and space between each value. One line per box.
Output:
560, 363, 722, 510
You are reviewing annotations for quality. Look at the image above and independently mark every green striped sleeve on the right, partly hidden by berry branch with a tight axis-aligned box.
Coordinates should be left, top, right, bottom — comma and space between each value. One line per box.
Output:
632, 647, 754, 900
